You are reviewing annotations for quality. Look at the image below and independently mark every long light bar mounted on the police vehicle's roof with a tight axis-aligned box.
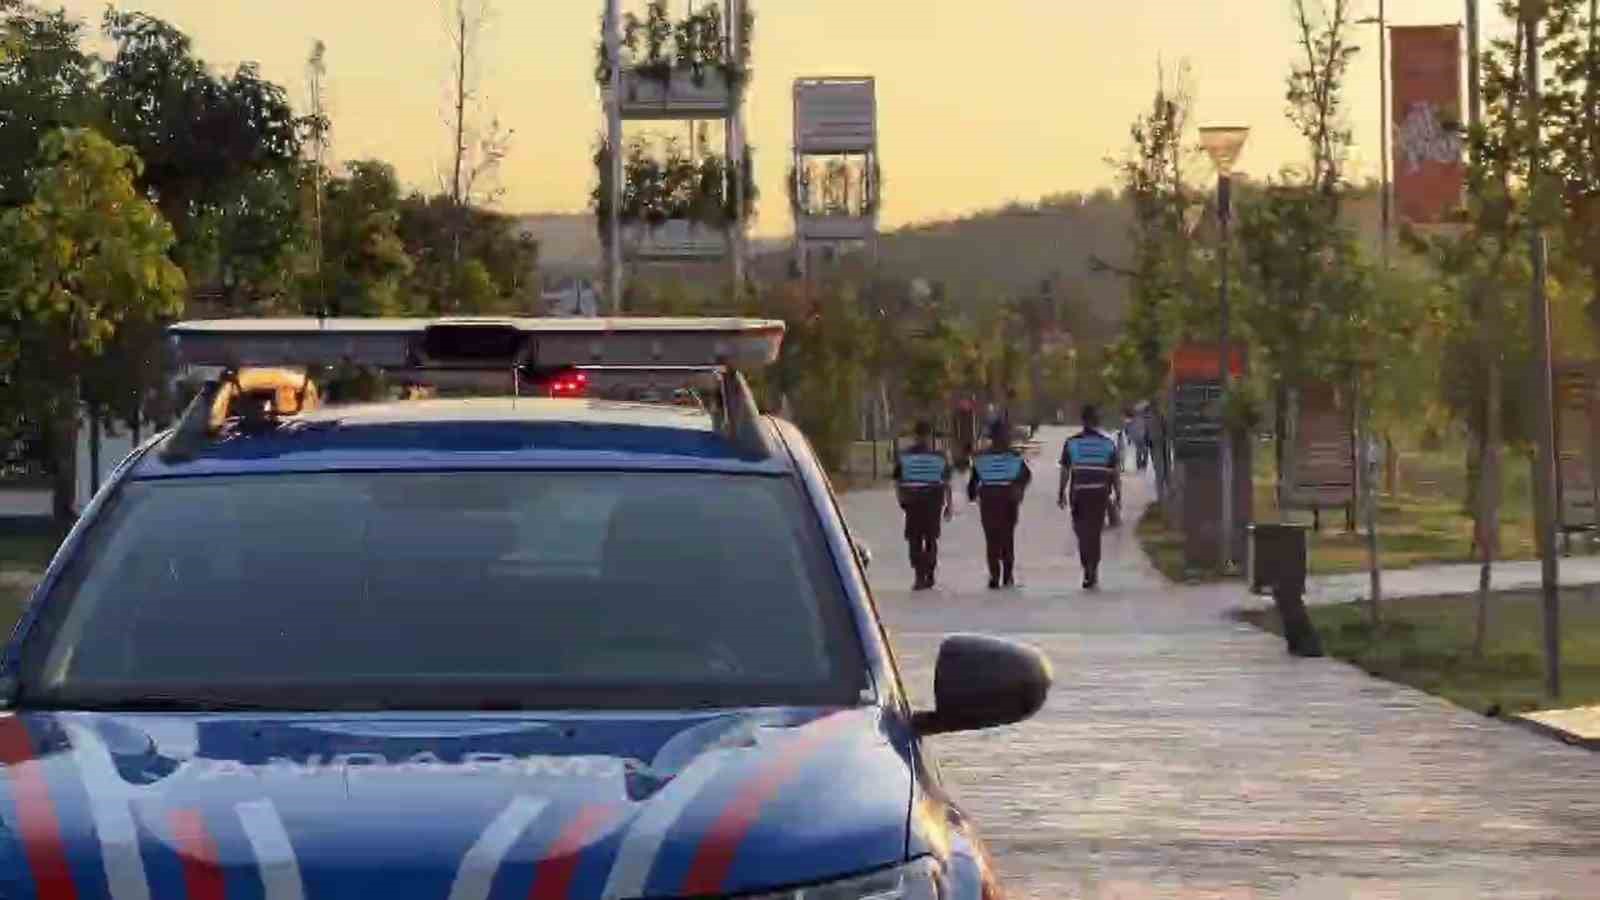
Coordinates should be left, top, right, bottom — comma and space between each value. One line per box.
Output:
168, 319, 784, 372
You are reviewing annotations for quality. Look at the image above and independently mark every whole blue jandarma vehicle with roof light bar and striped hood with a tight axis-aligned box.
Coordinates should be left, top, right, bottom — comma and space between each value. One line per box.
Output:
0, 319, 1050, 900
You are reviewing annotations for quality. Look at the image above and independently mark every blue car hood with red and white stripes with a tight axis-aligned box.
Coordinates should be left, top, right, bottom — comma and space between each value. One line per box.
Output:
0, 708, 910, 900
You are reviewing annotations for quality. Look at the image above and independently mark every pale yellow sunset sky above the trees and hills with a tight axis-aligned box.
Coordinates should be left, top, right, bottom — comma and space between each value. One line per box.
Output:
66, 0, 1493, 234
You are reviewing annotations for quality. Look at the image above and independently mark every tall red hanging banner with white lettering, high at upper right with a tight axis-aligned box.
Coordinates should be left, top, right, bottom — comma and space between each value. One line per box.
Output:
1389, 26, 1466, 224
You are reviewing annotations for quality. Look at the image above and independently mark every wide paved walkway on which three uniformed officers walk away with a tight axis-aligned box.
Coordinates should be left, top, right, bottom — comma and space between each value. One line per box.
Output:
845, 431, 1600, 900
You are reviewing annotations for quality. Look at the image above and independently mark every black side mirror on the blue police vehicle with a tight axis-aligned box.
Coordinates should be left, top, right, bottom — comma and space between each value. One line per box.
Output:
912, 634, 1054, 735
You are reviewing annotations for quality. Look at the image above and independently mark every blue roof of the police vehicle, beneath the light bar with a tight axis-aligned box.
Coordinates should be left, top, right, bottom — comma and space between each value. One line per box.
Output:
130, 397, 790, 479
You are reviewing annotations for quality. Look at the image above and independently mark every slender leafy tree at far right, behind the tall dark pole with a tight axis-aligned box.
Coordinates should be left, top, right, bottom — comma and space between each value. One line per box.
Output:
1410, 0, 1600, 653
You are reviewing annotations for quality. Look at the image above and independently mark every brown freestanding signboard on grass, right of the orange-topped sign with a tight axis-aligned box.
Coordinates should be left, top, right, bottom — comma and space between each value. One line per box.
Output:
1282, 377, 1355, 509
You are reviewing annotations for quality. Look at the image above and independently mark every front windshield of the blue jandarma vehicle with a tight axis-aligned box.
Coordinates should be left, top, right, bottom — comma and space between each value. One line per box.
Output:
24, 472, 866, 709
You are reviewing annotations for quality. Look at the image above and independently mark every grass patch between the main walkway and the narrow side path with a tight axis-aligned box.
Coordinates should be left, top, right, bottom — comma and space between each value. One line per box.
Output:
1242, 589, 1600, 714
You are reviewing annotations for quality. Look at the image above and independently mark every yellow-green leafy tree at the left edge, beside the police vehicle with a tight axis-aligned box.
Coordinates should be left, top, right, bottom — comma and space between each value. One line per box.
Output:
0, 128, 184, 527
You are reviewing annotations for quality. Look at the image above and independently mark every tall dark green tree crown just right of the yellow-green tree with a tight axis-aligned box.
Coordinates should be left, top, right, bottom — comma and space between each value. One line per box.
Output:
99, 10, 307, 311
